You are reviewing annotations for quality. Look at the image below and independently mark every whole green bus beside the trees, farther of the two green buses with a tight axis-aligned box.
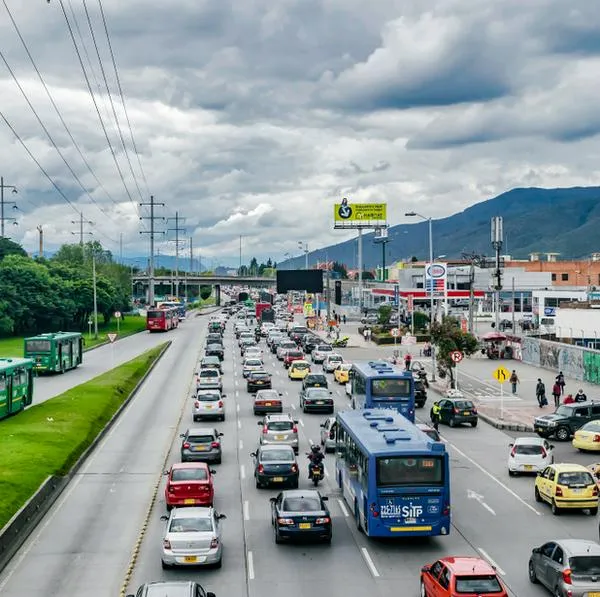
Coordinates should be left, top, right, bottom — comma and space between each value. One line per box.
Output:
24, 332, 83, 373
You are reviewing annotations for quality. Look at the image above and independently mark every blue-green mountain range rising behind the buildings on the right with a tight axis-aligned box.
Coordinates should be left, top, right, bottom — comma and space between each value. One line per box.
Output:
279, 187, 600, 270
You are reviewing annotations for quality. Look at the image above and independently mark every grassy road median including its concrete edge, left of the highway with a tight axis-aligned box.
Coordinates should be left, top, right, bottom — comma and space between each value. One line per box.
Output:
0, 342, 171, 570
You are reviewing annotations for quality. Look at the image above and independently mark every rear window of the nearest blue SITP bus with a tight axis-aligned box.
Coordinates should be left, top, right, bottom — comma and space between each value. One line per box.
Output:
377, 456, 444, 487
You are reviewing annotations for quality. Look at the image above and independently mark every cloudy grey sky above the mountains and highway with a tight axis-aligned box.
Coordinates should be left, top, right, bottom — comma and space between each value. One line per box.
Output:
0, 0, 600, 264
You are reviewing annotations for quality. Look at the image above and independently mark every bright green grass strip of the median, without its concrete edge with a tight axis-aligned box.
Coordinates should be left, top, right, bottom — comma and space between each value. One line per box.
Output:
0, 344, 165, 529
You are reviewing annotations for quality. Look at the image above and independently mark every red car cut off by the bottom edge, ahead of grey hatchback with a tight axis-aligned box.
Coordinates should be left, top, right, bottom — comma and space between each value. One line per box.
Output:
420, 557, 508, 597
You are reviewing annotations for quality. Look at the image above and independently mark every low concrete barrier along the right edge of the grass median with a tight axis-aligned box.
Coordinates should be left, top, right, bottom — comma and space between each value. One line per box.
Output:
0, 340, 171, 572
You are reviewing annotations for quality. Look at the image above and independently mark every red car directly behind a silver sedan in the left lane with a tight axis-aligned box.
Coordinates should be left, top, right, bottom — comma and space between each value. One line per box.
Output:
165, 462, 215, 510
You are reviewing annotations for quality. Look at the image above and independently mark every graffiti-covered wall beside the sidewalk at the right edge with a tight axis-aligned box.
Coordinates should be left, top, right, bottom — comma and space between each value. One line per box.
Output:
520, 337, 600, 385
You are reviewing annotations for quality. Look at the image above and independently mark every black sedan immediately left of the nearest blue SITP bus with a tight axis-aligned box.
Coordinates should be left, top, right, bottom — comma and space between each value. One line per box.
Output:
271, 489, 332, 543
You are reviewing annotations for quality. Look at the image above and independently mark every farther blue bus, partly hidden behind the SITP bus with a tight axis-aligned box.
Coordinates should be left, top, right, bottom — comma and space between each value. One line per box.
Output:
350, 361, 415, 423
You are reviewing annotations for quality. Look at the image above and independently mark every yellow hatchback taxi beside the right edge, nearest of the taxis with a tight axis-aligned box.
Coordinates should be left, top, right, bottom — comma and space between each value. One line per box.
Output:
535, 463, 598, 516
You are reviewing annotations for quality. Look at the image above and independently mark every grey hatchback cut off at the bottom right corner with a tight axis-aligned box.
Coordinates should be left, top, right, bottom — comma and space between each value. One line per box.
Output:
529, 539, 600, 597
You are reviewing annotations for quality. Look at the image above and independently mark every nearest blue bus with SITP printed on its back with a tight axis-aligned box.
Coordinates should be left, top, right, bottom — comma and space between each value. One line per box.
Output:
336, 409, 450, 537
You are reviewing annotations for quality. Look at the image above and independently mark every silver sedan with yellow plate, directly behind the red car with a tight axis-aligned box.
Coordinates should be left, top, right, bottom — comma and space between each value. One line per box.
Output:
161, 507, 226, 568
